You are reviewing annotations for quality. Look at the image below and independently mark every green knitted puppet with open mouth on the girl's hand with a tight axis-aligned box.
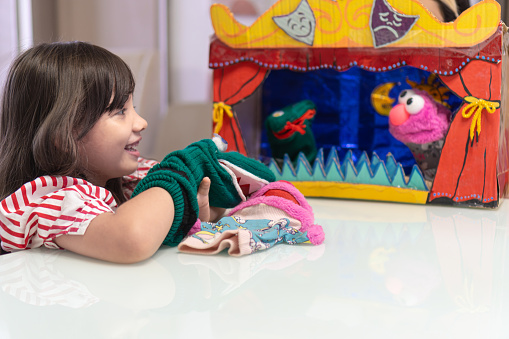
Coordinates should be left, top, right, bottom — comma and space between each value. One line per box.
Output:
132, 136, 275, 246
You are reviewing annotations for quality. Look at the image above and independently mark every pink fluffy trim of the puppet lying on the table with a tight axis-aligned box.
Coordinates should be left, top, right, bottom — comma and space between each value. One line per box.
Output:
228, 180, 325, 245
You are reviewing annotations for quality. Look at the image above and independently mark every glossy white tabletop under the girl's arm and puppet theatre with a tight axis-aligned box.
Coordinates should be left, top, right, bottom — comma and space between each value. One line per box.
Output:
0, 199, 509, 339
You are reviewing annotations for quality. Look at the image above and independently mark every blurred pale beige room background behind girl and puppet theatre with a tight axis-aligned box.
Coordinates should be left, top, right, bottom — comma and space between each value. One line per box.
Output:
0, 0, 500, 159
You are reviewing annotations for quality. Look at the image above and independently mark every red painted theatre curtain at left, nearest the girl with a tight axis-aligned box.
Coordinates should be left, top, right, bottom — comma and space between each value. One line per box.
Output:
213, 62, 268, 155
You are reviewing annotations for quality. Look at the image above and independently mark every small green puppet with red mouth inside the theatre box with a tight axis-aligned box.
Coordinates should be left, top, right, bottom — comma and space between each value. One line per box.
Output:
265, 100, 317, 164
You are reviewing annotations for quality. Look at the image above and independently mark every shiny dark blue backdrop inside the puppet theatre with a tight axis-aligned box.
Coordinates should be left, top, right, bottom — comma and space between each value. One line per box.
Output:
261, 67, 461, 174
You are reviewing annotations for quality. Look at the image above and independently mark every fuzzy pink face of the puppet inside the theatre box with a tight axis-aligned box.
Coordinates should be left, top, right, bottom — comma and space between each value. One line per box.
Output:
389, 89, 452, 144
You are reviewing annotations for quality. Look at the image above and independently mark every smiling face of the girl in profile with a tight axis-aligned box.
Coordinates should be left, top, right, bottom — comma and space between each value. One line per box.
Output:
81, 95, 147, 187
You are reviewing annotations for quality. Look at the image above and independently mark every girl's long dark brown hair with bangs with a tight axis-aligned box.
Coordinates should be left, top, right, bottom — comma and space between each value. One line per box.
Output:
0, 42, 135, 203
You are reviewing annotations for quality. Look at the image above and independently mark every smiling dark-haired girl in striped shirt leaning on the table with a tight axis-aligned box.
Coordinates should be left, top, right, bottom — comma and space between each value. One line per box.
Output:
0, 42, 270, 263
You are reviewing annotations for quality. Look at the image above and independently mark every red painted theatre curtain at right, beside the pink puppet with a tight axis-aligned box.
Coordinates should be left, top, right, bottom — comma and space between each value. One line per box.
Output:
429, 60, 502, 206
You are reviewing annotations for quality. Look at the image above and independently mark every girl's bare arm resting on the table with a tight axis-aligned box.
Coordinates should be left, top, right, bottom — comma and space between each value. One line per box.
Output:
55, 180, 210, 263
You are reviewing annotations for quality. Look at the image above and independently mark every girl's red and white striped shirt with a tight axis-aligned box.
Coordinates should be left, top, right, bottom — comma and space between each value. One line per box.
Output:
0, 158, 157, 252
